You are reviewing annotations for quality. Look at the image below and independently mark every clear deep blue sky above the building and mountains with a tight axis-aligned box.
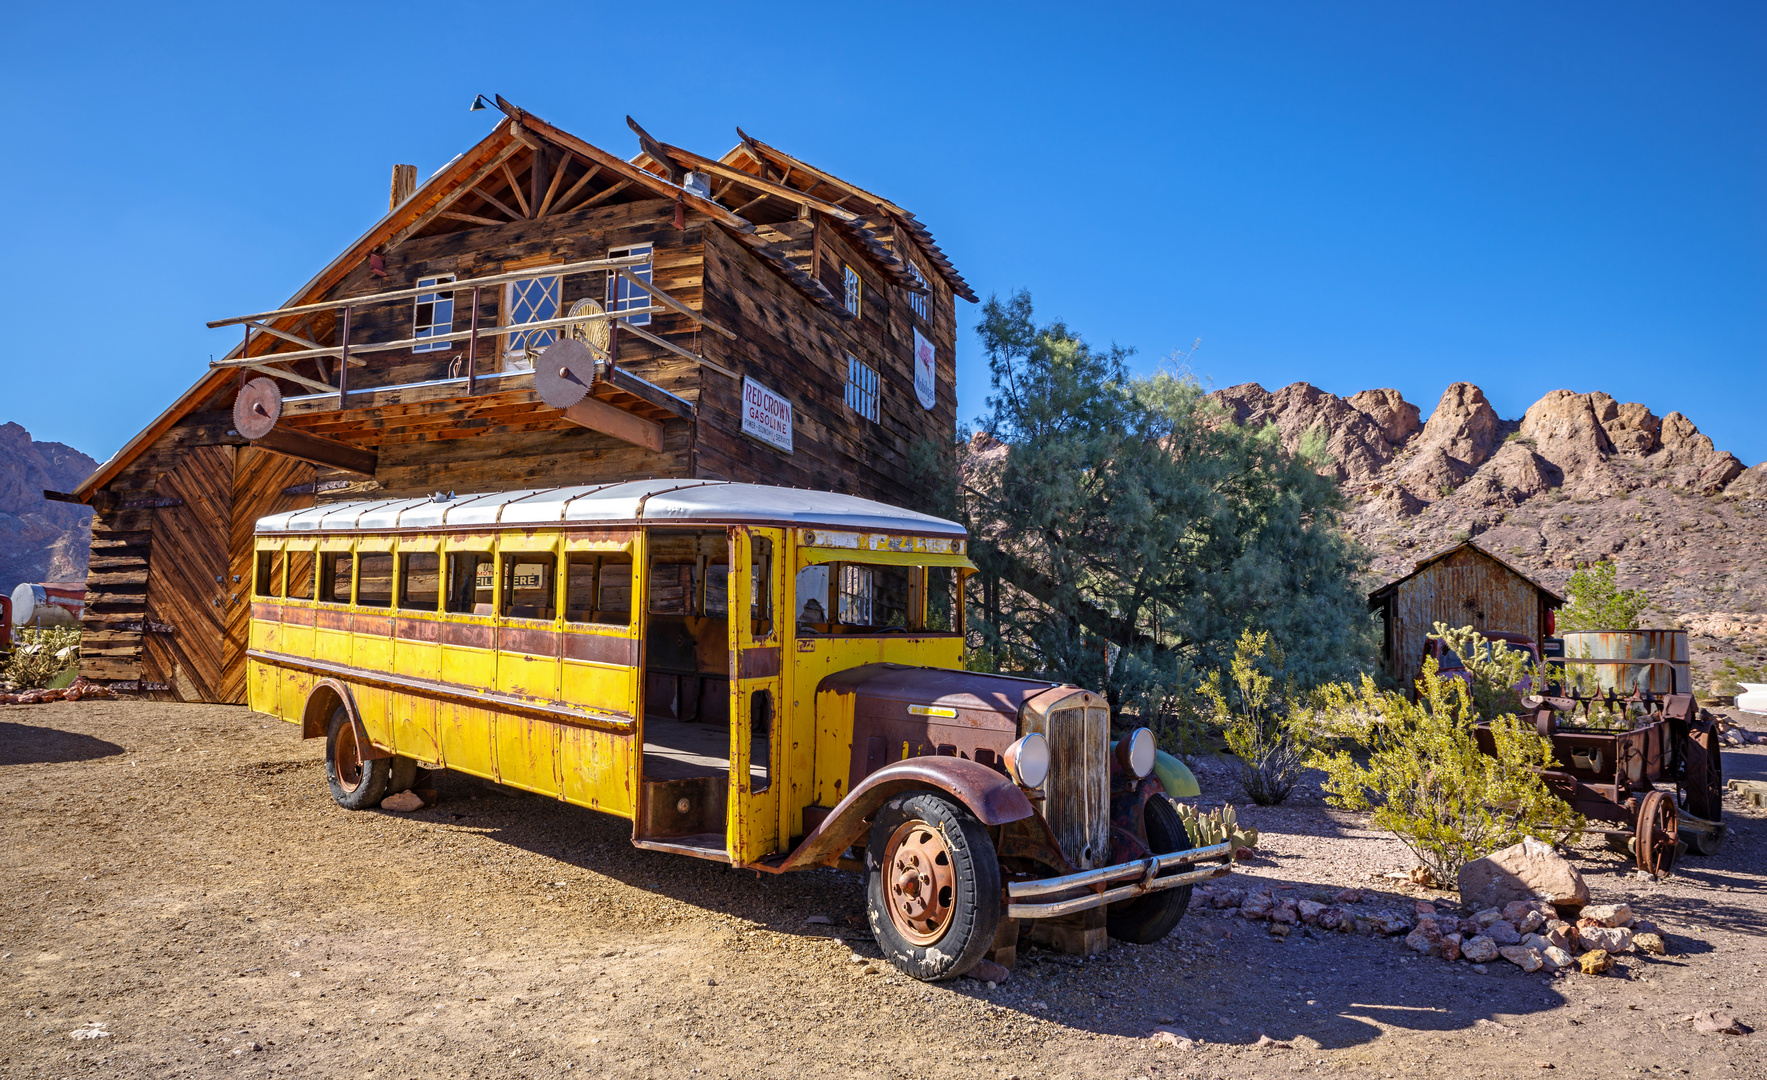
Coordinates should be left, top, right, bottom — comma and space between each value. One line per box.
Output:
0, 4, 1767, 465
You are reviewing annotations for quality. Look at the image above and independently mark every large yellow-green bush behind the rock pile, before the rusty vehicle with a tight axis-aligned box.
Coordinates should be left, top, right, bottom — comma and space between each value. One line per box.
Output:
1309, 659, 1583, 882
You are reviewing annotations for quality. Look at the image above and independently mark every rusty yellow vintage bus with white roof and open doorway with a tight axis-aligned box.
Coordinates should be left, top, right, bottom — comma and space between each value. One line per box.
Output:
247, 479, 1228, 979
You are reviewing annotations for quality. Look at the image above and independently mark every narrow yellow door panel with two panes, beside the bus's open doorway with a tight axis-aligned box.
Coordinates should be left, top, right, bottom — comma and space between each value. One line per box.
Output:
728, 525, 790, 864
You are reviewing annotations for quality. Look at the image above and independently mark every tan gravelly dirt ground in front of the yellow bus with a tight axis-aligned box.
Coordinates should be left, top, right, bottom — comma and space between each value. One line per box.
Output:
0, 702, 1767, 1080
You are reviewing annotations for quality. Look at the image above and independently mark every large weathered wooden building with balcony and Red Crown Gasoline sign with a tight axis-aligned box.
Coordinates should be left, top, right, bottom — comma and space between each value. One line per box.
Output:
51, 97, 975, 702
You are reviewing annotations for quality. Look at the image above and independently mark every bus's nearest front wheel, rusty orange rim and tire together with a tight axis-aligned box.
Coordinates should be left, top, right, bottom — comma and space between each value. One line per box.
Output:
866, 792, 1000, 983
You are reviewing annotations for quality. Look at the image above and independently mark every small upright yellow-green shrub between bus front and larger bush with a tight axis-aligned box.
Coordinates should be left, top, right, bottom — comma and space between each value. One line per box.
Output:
1202, 629, 1311, 806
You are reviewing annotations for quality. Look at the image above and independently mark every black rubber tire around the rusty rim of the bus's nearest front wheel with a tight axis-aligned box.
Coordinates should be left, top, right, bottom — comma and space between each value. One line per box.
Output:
866, 792, 1000, 983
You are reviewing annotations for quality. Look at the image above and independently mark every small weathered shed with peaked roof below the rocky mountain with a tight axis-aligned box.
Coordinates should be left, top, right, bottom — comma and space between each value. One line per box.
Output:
1368, 541, 1564, 689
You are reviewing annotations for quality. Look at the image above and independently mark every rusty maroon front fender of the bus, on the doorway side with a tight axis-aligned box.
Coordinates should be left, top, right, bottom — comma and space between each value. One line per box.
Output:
779, 757, 1032, 871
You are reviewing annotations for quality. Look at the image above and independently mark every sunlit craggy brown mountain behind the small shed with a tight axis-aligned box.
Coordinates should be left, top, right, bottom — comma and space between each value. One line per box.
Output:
1210, 382, 1767, 689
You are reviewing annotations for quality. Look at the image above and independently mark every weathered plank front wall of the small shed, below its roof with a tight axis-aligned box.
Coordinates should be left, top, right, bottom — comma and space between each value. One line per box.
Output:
1387, 548, 1541, 686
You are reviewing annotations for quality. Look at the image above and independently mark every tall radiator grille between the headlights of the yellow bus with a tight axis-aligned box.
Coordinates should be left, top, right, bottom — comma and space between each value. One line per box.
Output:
1025, 695, 1110, 870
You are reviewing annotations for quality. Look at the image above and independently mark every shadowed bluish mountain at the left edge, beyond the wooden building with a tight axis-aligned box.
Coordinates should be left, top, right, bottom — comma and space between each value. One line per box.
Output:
0, 424, 99, 596
